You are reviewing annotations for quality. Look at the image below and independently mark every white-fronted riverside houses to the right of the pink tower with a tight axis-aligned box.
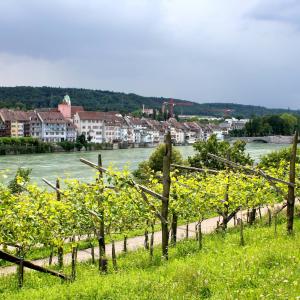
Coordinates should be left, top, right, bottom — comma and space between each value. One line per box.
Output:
74, 111, 212, 144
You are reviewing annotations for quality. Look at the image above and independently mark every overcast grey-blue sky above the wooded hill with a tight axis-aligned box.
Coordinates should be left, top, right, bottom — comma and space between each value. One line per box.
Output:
0, 0, 300, 109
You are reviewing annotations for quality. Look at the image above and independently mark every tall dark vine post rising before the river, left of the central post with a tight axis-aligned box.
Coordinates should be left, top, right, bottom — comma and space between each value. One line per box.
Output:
98, 154, 107, 272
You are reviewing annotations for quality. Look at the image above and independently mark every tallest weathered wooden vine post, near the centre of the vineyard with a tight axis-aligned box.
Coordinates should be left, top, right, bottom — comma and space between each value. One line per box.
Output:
161, 131, 172, 260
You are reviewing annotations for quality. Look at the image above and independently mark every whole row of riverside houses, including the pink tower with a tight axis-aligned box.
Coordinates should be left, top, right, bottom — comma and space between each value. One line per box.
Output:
0, 95, 232, 144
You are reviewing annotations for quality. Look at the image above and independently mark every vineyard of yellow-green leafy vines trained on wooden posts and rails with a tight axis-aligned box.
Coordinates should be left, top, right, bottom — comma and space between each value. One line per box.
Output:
0, 133, 300, 296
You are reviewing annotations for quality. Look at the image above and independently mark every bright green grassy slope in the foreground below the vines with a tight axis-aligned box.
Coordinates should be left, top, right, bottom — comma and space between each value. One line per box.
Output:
0, 217, 300, 299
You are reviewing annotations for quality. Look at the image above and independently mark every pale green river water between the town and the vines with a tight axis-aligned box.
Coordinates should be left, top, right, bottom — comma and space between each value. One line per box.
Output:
0, 143, 287, 184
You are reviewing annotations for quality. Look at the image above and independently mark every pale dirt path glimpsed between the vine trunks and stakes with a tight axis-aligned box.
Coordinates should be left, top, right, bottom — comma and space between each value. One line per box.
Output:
0, 208, 267, 276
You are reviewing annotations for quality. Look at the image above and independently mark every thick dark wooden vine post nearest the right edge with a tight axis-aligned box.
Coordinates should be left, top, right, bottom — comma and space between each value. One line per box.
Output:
286, 130, 298, 234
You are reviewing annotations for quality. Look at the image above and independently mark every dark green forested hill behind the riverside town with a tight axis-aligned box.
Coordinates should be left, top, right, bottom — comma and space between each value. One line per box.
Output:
0, 86, 300, 117
